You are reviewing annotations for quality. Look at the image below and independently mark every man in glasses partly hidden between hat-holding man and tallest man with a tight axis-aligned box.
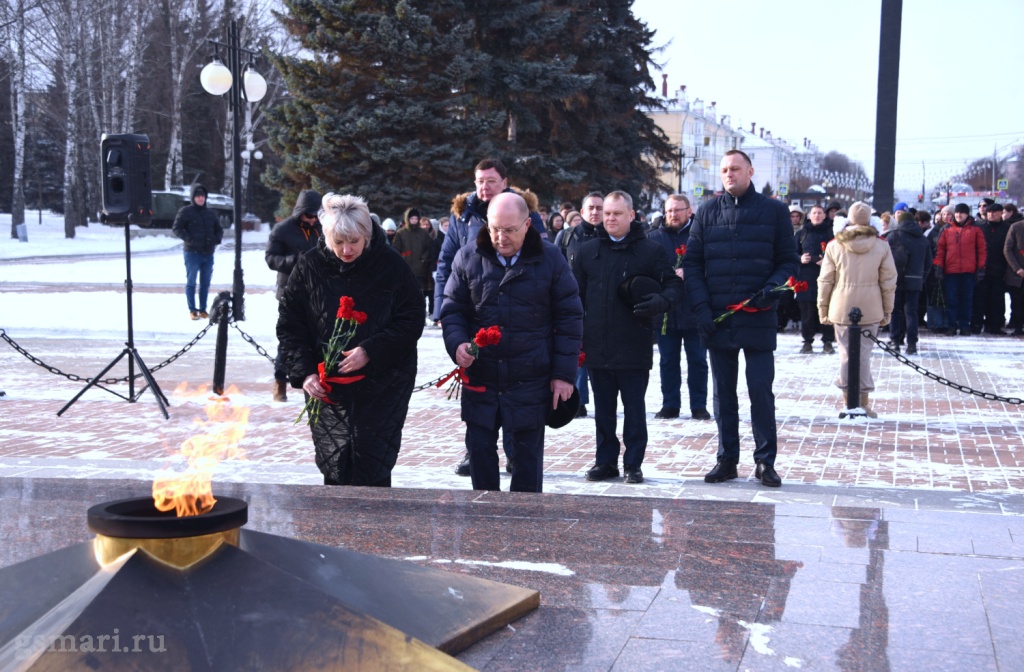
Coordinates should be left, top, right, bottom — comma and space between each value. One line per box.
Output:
647, 194, 711, 420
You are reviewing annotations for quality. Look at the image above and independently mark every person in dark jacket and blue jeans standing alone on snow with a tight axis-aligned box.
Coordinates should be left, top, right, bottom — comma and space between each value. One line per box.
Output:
172, 184, 224, 320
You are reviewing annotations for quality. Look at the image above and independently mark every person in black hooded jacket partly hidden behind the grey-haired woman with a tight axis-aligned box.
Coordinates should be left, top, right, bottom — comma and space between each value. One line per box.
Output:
265, 190, 324, 402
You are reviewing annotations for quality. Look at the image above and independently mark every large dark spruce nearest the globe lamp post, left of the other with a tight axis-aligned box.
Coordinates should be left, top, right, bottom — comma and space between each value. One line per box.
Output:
264, 0, 502, 216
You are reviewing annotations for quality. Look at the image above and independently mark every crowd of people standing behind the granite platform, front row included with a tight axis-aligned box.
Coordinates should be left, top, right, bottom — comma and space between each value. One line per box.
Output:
249, 154, 1024, 492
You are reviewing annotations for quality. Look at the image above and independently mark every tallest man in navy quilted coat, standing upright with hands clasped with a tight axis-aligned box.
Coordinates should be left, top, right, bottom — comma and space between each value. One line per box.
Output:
683, 150, 800, 487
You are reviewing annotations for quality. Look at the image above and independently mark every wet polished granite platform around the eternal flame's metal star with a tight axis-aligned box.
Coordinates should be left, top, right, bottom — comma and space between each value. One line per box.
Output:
0, 478, 1024, 671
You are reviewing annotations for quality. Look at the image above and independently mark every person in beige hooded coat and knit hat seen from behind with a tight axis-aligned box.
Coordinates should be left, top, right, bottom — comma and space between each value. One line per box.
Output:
818, 202, 896, 418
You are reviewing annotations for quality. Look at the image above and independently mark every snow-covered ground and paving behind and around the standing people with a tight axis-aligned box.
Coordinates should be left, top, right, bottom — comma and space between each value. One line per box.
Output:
0, 212, 1024, 504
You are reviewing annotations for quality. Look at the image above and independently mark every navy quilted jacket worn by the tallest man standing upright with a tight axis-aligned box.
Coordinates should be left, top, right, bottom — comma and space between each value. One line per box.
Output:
683, 184, 800, 350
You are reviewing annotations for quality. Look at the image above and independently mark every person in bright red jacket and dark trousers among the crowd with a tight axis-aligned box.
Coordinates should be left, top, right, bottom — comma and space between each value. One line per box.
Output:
934, 203, 985, 336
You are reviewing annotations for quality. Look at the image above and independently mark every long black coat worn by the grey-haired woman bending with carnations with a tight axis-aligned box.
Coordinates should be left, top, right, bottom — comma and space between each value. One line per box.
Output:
278, 225, 423, 486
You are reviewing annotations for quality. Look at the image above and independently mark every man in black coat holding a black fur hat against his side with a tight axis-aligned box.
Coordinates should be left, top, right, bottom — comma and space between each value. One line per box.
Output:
572, 192, 683, 484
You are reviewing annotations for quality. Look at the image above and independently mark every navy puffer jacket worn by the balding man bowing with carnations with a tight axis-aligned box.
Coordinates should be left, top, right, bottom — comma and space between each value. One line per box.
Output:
440, 228, 583, 430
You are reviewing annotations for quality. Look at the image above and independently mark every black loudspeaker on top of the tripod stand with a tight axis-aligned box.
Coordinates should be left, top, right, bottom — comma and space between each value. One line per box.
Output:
99, 133, 153, 224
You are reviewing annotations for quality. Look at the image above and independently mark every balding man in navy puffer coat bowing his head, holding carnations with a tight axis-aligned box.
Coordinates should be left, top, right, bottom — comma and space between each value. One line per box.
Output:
440, 194, 583, 493
